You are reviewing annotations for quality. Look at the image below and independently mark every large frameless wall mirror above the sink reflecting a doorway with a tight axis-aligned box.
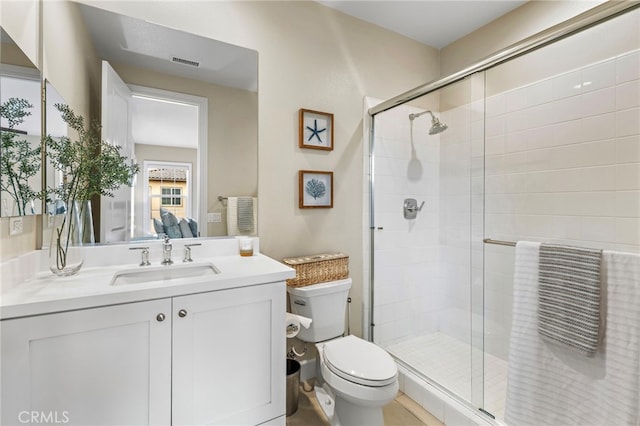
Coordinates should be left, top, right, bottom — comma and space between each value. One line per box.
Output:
42, 1, 258, 245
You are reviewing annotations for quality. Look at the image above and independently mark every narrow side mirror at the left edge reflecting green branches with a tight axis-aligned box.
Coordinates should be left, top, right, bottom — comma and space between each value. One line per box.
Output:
0, 27, 42, 217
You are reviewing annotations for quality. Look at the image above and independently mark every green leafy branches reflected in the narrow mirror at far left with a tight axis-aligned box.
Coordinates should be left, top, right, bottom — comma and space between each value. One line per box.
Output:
0, 98, 41, 216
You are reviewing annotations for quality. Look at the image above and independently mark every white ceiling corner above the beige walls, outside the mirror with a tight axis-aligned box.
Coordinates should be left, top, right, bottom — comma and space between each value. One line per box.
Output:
318, 0, 526, 49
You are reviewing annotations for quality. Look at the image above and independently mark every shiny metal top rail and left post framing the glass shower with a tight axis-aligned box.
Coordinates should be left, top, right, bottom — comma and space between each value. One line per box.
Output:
364, 0, 640, 420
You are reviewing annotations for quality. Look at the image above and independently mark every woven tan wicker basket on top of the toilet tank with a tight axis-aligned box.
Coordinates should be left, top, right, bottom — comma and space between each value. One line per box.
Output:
282, 253, 349, 287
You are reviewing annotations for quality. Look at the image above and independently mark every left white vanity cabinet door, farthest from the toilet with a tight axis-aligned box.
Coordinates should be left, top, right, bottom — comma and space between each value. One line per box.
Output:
0, 299, 171, 425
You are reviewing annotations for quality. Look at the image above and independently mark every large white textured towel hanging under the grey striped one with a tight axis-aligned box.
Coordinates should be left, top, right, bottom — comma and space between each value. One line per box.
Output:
505, 242, 640, 426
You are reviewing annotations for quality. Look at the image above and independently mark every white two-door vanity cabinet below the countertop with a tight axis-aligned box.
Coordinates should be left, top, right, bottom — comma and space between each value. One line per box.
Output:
0, 282, 286, 425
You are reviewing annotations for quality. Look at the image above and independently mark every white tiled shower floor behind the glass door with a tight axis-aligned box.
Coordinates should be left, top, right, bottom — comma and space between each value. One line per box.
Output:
385, 332, 507, 419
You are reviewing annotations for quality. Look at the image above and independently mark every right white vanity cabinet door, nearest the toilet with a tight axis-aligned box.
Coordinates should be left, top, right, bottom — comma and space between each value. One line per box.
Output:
172, 283, 286, 425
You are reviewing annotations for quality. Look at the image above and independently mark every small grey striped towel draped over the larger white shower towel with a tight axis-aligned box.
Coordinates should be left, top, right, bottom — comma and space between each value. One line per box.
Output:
538, 244, 602, 355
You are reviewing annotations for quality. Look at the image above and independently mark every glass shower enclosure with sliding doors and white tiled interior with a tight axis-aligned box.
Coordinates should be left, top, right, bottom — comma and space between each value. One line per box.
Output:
366, 1, 640, 420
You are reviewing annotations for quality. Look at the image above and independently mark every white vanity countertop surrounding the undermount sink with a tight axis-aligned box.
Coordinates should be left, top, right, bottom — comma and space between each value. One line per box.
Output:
0, 240, 295, 320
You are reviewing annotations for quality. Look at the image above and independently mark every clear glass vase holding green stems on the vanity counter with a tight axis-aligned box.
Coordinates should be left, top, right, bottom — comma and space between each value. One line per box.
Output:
49, 201, 84, 276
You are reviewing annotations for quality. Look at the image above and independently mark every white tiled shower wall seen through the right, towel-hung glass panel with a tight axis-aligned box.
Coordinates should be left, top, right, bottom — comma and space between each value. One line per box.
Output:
474, 50, 640, 355
